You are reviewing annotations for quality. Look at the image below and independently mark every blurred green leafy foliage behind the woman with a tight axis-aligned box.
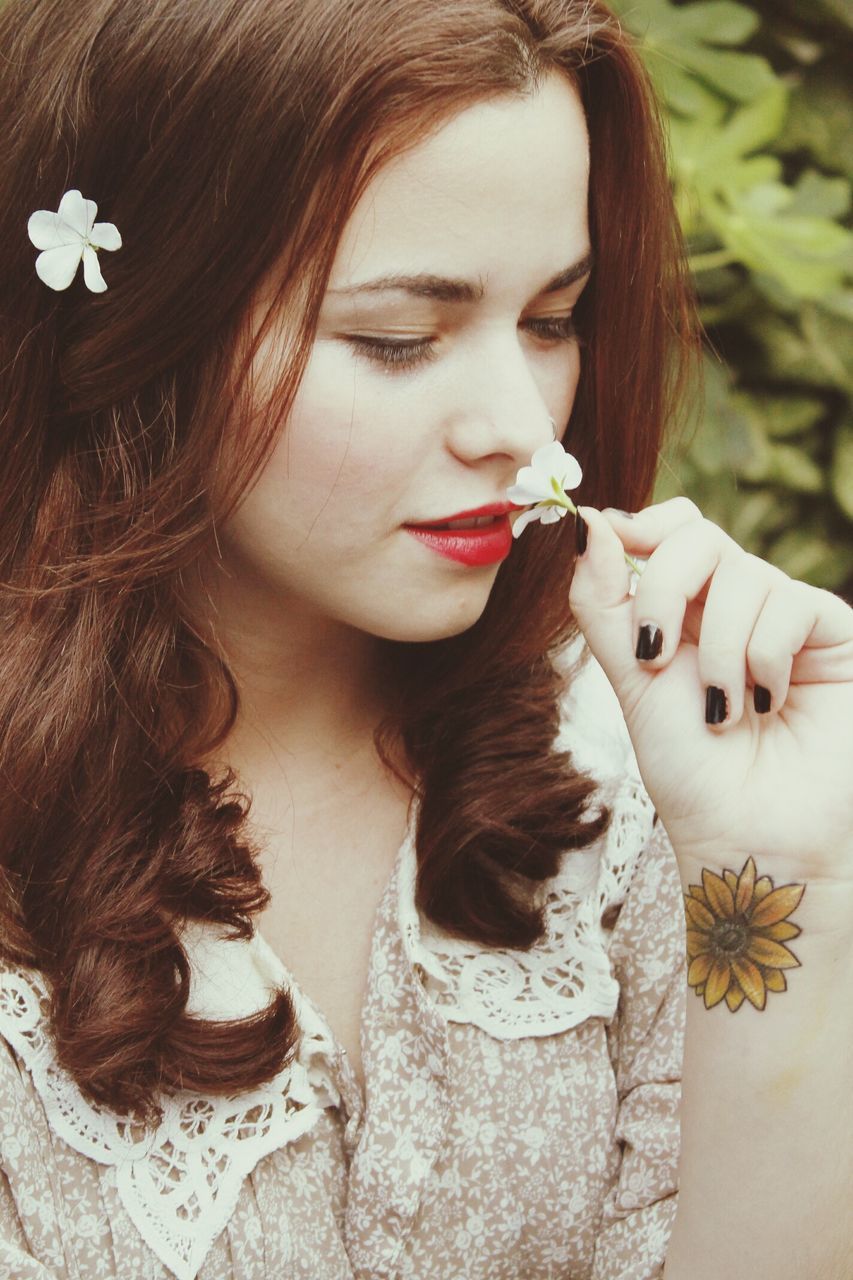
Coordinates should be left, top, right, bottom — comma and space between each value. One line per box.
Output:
611, 0, 853, 598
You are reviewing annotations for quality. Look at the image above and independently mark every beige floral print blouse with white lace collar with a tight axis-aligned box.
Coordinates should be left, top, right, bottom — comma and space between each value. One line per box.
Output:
0, 645, 685, 1280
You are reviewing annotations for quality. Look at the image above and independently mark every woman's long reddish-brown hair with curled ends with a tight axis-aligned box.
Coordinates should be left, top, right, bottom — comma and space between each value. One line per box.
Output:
0, 0, 690, 1114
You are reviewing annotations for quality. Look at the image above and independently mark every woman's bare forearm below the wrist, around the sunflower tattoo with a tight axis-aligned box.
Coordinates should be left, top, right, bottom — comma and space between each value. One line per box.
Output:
665, 859, 853, 1280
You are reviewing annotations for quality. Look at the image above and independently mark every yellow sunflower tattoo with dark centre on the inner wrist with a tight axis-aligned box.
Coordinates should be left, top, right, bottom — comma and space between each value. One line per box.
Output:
684, 858, 806, 1012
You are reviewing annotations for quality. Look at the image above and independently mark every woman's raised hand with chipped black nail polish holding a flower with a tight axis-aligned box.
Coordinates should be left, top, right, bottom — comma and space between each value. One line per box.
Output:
570, 498, 853, 884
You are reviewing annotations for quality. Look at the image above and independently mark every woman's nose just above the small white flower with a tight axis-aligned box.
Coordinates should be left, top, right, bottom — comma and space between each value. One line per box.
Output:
450, 339, 565, 466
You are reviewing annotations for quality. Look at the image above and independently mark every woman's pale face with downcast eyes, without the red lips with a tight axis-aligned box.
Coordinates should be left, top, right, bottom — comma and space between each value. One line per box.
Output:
220, 74, 589, 641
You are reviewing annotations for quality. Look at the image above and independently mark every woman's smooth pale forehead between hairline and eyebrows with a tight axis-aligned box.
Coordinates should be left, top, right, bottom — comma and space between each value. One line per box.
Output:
329, 73, 589, 291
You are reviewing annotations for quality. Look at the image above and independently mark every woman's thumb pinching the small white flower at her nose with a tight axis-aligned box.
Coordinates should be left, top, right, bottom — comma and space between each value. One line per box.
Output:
569, 507, 648, 712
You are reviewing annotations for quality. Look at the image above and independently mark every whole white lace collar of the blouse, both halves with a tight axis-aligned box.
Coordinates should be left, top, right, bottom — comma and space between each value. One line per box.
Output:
0, 649, 652, 1280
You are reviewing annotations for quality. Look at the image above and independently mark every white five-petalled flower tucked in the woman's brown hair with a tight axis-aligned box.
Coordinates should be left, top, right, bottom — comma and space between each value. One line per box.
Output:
27, 191, 122, 293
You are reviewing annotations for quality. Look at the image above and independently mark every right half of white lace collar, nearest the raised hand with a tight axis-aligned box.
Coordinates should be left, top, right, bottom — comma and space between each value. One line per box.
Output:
398, 650, 654, 1039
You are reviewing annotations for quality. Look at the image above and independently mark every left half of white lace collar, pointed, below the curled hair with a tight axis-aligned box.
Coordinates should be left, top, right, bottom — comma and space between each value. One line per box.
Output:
0, 942, 338, 1280
